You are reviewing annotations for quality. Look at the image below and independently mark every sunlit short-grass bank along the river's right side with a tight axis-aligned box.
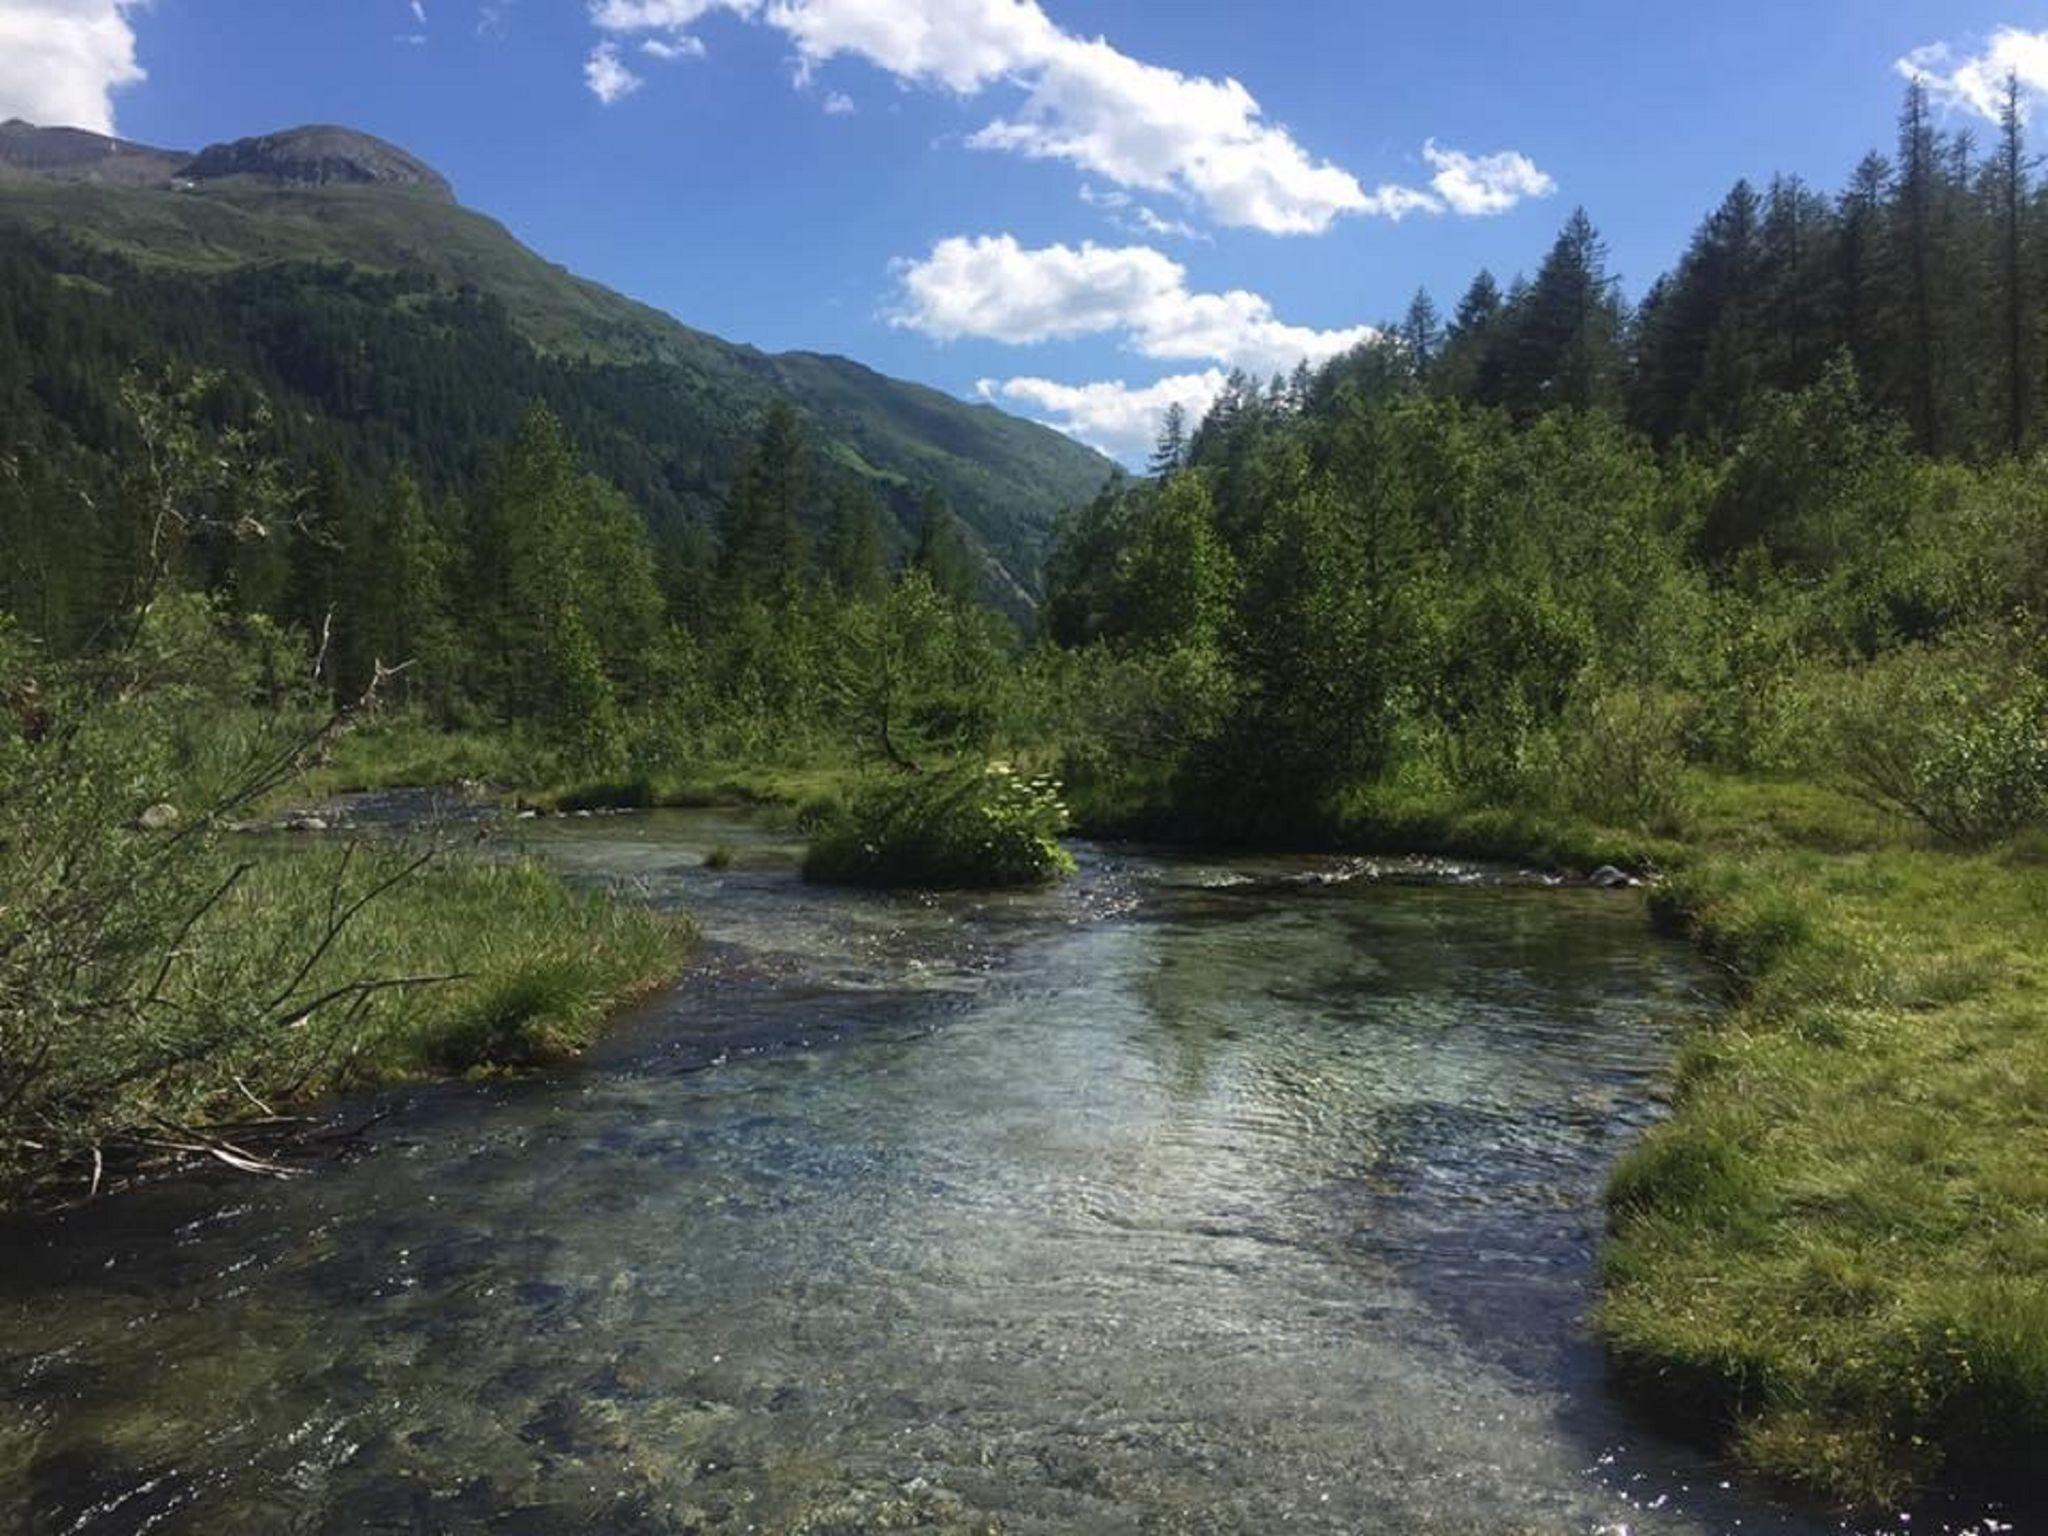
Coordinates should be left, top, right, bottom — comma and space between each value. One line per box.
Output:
1310, 780, 2048, 1507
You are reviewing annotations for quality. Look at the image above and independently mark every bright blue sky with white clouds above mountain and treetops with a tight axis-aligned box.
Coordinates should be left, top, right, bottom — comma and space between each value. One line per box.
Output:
0, 0, 2048, 459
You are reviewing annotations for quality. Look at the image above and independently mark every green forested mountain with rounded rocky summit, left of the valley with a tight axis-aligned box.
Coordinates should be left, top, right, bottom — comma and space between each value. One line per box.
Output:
0, 121, 1114, 610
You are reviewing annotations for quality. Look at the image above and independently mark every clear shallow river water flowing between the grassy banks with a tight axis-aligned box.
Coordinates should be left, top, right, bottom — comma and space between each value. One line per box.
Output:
0, 813, 1916, 1536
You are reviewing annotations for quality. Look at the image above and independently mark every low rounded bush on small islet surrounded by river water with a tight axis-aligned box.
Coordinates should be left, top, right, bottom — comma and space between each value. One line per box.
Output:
803, 764, 1073, 889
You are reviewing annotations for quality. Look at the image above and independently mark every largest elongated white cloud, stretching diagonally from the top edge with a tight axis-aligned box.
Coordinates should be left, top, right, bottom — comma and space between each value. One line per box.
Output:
590, 0, 1548, 236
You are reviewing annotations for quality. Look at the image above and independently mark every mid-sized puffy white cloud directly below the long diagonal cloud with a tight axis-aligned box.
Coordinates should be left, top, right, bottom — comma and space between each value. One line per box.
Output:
891, 236, 1376, 373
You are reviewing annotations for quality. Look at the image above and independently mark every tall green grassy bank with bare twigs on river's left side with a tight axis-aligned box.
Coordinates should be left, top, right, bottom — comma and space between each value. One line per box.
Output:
0, 842, 690, 1206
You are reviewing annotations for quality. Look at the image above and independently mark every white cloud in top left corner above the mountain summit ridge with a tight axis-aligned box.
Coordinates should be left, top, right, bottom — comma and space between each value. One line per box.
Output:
0, 0, 145, 133
